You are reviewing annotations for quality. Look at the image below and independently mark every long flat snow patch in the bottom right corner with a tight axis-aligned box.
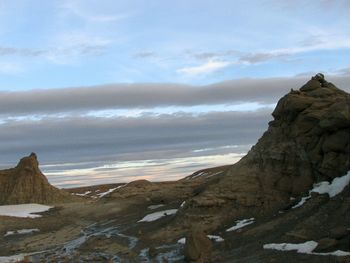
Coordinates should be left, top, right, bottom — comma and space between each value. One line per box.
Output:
263, 240, 350, 257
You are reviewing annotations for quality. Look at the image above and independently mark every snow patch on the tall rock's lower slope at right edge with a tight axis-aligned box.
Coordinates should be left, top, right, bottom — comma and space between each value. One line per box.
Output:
292, 171, 350, 209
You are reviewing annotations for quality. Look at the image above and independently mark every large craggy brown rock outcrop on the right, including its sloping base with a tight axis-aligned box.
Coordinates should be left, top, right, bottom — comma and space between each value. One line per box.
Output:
187, 74, 350, 225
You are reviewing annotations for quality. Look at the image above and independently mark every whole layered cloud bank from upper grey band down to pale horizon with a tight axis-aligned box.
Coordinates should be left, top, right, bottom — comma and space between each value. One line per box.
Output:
0, 75, 350, 186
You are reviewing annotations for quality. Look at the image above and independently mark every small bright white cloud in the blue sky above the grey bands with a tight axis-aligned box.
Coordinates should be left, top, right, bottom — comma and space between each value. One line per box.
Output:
177, 60, 231, 77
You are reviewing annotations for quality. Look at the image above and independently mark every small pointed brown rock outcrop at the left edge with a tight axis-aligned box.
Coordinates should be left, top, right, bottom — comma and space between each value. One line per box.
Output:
0, 153, 72, 205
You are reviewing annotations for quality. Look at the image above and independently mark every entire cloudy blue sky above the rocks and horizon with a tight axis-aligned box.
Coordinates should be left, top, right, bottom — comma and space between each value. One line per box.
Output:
0, 0, 350, 187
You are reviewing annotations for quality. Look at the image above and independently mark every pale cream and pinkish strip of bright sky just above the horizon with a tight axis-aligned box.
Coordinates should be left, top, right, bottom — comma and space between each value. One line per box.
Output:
43, 153, 245, 188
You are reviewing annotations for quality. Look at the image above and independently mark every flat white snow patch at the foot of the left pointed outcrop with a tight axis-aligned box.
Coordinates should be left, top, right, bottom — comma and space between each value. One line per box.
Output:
0, 204, 53, 218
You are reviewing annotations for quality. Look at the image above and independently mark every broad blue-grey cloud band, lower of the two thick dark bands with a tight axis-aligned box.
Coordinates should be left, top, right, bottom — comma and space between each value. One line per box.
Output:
0, 109, 271, 168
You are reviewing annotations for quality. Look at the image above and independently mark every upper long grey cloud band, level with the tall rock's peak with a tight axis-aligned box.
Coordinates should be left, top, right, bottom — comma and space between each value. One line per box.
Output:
0, 75, 350, 116
